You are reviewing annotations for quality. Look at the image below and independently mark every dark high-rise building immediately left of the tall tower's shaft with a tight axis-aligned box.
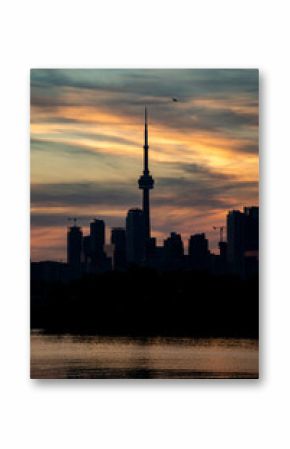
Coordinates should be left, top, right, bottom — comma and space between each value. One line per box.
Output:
126, 208, 146, 264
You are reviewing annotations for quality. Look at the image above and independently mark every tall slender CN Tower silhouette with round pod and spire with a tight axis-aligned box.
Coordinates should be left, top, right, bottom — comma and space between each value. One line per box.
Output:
138, 107, 154, 239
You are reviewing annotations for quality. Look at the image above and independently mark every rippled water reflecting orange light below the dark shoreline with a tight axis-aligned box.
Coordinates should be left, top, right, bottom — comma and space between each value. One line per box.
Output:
31, 332, 258, 379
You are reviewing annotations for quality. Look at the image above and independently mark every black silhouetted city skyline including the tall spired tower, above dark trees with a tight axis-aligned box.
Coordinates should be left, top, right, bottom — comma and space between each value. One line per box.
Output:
64, 108, 259, 277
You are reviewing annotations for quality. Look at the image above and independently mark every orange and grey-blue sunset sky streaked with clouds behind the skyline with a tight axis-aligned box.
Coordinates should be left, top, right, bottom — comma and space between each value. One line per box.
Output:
31, 69, 259, 260
